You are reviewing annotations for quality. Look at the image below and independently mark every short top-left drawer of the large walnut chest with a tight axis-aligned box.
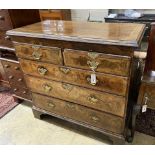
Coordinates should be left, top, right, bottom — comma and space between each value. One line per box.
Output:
14, 43, 63, 64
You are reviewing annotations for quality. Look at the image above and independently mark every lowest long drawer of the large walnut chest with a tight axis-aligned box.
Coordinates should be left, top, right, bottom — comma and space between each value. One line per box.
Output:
33, 94, 123, 133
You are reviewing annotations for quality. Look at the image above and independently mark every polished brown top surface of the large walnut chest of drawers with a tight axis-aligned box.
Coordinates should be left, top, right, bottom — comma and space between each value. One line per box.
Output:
7, 20, 145, 47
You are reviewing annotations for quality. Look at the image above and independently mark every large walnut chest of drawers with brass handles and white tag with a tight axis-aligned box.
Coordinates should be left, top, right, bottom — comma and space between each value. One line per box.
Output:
7, 21, 145, 144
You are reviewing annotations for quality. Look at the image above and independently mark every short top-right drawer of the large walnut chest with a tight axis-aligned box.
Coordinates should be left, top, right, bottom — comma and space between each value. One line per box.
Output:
63, 49, 130, 76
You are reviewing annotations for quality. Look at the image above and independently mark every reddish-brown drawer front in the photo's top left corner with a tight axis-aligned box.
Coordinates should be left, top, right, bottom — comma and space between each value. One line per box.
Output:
0, 10, 13, 31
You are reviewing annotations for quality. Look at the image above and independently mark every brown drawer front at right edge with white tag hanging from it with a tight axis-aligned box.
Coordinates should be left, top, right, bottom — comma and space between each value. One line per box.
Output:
142, 84, 155, 109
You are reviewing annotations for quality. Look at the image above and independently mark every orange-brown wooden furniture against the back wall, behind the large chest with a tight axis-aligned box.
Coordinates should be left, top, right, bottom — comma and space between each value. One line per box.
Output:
39, 9, 71, 21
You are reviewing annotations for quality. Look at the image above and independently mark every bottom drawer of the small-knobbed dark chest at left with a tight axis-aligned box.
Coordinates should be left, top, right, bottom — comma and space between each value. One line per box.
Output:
11, 85, 32, 100
